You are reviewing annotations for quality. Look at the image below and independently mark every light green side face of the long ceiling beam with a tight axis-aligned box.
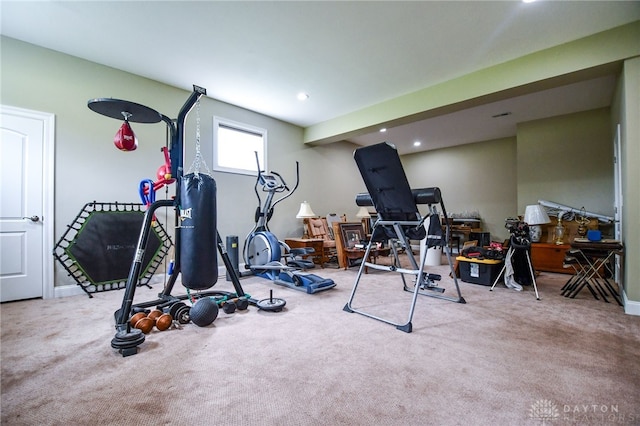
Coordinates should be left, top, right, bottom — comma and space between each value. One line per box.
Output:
304, 21, 640, 144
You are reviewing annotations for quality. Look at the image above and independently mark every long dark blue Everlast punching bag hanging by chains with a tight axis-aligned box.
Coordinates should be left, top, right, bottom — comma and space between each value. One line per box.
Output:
179, 173, 218, 290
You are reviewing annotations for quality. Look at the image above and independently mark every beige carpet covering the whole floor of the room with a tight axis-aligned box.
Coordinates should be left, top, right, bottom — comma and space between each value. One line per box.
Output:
0, 256, 640, 425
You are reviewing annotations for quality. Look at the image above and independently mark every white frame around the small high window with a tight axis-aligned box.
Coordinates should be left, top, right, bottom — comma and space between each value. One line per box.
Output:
213, 116, 267, 176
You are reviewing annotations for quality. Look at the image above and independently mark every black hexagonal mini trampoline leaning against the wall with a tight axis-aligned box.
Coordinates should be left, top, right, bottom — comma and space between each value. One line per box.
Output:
54, 201, 172, 297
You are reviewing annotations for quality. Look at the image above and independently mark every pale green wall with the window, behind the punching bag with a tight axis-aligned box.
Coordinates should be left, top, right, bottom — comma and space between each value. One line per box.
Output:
0, 37, 363, 286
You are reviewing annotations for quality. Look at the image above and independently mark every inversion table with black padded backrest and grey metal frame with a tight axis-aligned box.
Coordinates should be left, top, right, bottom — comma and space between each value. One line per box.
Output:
343, 142, 466, 333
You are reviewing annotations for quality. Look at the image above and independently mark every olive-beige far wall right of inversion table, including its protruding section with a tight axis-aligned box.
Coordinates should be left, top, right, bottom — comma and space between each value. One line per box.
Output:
403, 108, 613, 245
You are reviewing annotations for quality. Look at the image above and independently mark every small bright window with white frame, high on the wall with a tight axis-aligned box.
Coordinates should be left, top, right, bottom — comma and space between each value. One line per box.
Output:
213, 117, 267, 176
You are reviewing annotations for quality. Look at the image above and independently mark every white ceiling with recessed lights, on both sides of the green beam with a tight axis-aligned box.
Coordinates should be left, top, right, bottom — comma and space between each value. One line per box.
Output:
0, 0, 640, 153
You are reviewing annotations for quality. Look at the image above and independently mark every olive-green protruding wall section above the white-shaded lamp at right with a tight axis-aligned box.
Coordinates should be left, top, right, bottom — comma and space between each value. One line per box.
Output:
517, 108, 613, 217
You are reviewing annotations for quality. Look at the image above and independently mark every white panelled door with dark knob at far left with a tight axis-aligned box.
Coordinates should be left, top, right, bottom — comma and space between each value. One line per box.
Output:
0, 106, 54, 302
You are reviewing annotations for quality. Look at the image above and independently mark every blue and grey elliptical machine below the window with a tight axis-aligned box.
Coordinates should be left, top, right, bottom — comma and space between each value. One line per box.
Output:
241, 152, 336, 294
